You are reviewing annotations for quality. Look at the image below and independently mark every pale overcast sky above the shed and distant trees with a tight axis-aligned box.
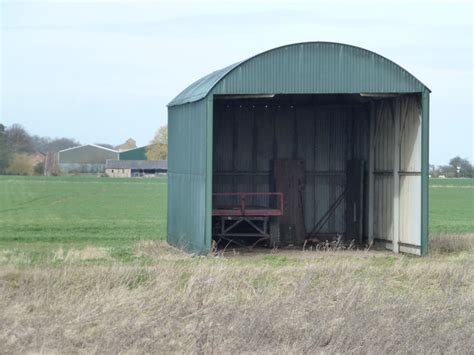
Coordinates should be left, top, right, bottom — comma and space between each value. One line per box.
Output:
0, 0, 474, 164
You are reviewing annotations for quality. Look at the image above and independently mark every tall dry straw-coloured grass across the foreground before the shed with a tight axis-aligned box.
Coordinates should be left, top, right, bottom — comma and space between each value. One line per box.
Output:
0, 238, 474, 354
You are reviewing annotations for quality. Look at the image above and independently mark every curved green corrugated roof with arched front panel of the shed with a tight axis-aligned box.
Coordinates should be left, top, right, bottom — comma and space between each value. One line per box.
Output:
168, 42, 430, 106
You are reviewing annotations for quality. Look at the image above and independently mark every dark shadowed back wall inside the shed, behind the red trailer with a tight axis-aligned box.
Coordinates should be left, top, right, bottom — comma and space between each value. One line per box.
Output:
213, 94, 373, 244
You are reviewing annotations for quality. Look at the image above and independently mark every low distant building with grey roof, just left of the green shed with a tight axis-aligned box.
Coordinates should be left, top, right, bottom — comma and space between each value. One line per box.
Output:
105, 160, 168, 178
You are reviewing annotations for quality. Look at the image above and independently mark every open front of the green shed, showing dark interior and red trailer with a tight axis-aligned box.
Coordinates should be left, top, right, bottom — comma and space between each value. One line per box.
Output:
212, 94, 421, 253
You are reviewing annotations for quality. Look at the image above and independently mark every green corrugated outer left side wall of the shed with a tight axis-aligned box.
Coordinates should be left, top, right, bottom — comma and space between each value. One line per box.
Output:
168, 100, 209, 252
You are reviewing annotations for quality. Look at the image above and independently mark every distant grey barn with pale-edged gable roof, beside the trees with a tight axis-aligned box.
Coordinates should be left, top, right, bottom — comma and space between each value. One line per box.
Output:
58, 144, 119, 173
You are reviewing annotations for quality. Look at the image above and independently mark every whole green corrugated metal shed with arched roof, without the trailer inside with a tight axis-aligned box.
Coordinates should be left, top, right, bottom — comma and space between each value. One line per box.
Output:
168, 42, 430, 254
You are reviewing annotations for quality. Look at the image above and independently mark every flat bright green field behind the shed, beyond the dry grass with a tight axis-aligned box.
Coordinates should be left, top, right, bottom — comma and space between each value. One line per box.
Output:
0, 176, 474, 262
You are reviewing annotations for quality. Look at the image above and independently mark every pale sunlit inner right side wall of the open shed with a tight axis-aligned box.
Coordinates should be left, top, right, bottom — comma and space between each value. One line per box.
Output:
374, 96, 421, 247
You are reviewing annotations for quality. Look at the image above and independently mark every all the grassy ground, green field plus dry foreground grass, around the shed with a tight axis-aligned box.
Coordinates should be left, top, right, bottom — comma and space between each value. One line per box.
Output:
0, 177, 474, 354
